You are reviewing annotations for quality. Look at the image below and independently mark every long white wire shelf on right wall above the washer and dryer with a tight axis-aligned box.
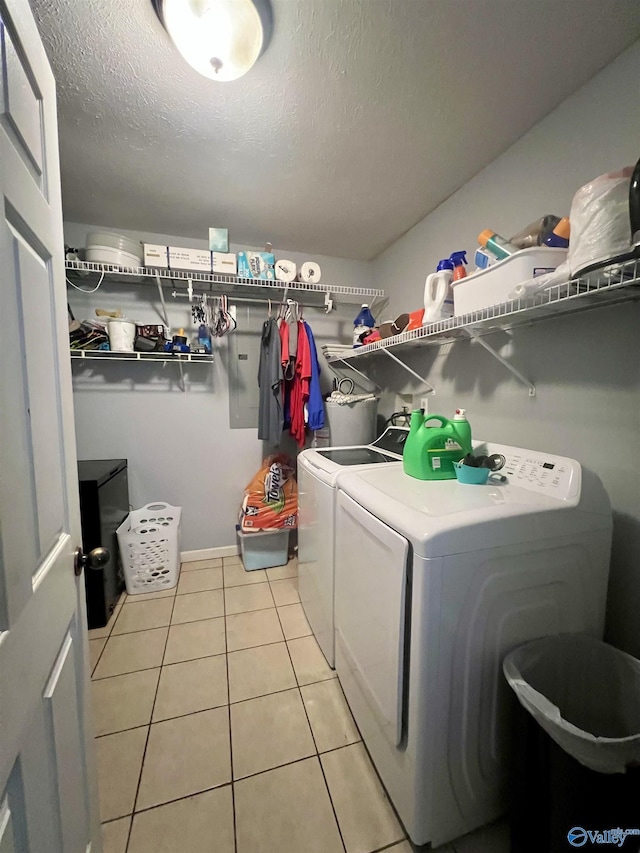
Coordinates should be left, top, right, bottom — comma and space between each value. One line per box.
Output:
327, 253, 640, 363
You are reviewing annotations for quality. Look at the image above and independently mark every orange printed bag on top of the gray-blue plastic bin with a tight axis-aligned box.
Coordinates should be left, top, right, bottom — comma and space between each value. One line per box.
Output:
240, 455, 298, 533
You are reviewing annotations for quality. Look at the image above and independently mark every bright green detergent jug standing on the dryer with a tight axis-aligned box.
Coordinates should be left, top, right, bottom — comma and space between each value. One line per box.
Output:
402, 409, 471, 480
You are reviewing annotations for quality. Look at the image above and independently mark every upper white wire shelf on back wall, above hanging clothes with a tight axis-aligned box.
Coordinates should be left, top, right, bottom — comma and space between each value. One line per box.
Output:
65, 261, 384, 301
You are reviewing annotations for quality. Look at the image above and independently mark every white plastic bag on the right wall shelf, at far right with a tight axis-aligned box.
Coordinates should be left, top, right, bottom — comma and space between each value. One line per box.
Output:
509, 166, 633, 299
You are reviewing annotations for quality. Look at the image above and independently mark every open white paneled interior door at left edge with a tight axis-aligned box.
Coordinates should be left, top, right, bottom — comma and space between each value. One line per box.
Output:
0, 0, 102, 853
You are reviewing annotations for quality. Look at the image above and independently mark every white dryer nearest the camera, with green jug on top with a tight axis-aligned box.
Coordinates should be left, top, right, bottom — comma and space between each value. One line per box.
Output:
335, 444, 611, 847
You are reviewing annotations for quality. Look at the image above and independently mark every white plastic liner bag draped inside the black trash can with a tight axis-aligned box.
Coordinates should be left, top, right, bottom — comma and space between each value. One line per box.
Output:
502, 634, 640, 773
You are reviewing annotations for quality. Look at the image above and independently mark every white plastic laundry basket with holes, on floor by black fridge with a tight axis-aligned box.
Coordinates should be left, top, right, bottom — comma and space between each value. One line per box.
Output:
117, 503, 182, 595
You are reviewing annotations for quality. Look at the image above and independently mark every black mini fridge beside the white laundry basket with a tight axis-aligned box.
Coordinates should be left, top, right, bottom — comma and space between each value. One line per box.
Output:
78, 459, 129, 628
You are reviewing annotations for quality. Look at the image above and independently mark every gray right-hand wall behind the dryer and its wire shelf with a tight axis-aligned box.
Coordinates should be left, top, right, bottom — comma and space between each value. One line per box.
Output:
367, 42, 640, 657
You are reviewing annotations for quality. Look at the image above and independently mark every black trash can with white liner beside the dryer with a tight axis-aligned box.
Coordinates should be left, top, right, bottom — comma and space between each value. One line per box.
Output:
503, 634, 640, 853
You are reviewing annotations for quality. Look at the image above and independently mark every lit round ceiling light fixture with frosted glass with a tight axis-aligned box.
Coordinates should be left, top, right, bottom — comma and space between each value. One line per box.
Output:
152, 0, 272, 82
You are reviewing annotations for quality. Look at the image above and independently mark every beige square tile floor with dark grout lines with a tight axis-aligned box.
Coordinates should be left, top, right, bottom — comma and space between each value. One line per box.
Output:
89, 557, 508, 853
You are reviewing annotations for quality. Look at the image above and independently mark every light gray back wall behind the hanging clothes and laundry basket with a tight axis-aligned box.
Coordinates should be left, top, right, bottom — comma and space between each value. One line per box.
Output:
65, 223, 371, 550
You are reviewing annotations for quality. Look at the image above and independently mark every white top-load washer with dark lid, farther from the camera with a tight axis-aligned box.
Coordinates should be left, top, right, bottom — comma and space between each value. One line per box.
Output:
298, 426, 409, 667
